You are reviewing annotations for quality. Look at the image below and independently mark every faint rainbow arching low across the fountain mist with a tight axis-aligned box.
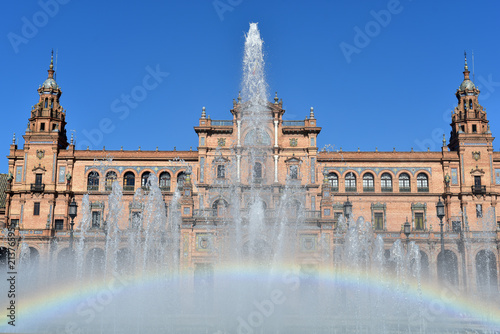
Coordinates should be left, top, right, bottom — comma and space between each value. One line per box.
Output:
0, 265, 500, 333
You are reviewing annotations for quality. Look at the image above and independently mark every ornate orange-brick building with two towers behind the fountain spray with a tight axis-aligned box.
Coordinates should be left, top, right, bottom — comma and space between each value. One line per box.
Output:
0, 53, 500, 290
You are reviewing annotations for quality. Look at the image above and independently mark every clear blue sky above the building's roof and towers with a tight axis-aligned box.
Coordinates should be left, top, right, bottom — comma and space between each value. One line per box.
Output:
0, 0, 500, 172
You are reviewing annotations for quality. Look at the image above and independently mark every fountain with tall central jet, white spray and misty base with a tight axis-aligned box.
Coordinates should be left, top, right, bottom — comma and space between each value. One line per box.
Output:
0, 24, 500, 334
